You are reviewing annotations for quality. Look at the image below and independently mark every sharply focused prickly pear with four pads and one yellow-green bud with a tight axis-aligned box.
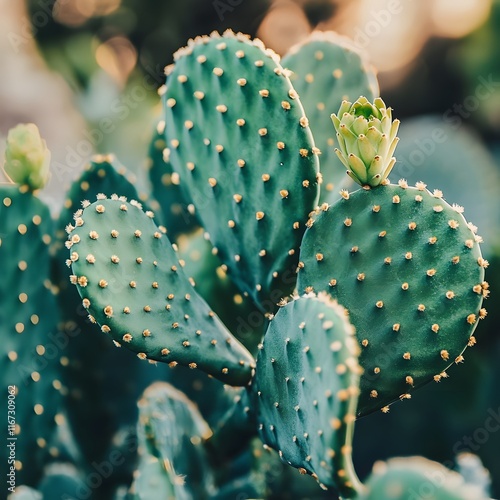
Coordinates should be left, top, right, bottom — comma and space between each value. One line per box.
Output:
60, 32, 489, 498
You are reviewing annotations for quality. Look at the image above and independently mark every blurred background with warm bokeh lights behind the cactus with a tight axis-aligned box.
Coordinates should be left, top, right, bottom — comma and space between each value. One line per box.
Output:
0, 0, 500, 497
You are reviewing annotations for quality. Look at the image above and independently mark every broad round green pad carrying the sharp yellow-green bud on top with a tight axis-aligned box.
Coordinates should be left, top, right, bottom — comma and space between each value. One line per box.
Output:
298, 181, 489, 416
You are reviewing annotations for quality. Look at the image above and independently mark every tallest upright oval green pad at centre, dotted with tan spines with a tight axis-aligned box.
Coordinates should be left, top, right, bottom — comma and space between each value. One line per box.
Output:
164, 32, 319, 311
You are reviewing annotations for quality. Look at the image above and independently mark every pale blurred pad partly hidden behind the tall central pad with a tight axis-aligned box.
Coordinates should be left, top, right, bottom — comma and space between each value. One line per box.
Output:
282, 31, 379, 199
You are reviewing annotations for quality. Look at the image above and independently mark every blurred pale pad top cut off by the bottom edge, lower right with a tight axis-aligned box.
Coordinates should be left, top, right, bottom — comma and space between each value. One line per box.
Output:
356, 457, 490, 500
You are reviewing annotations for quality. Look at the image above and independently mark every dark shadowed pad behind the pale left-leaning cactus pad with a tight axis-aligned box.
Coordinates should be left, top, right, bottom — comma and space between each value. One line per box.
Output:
52, 155, 170, 466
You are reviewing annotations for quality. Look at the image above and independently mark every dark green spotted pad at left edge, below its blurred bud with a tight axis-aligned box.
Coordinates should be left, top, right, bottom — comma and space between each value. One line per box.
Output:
0, 185, 65, 486
